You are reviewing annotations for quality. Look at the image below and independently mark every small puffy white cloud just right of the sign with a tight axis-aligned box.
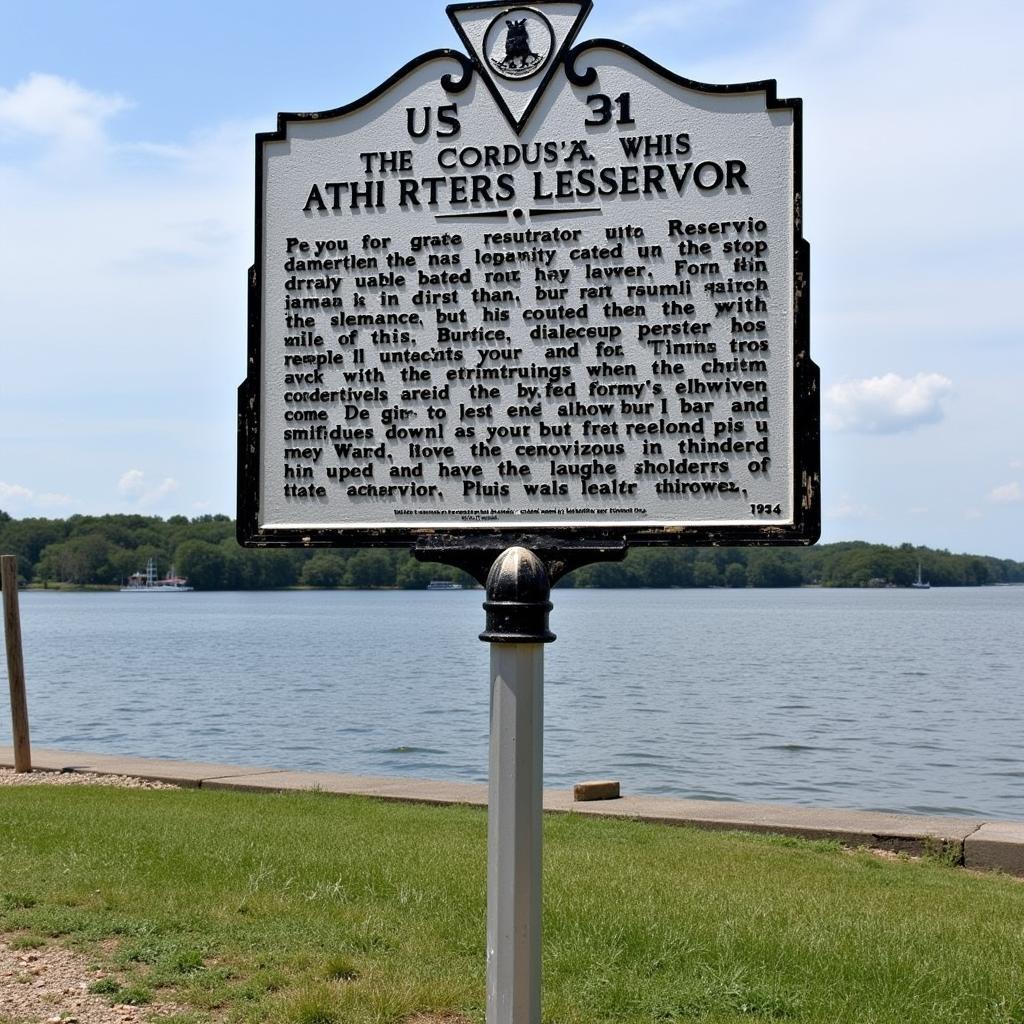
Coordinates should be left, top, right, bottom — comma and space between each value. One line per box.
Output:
824, 374, 952, 434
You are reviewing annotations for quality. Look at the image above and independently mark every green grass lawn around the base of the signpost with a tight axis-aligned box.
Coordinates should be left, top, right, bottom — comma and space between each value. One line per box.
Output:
0, 786, 1024, 1024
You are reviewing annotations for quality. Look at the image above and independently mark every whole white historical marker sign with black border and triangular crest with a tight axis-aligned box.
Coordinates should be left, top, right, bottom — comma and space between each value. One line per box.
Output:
239, 2, 819, 545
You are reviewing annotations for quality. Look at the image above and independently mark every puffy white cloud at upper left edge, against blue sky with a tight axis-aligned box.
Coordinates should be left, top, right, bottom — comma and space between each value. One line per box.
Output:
0, 74, 132, 147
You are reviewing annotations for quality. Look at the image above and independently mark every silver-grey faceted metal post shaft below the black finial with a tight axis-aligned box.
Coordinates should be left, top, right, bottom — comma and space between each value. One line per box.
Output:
486, 643, 544, 1024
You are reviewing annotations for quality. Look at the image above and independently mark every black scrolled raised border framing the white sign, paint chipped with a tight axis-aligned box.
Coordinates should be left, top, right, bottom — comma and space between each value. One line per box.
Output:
236, 39, 821, 550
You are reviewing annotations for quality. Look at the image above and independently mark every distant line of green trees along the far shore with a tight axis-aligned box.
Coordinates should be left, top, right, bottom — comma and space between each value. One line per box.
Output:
0, 511, 1024, 590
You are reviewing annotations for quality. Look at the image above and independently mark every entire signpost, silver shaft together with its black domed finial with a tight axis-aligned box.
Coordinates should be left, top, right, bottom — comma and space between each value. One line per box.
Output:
480, 548, 555, 1024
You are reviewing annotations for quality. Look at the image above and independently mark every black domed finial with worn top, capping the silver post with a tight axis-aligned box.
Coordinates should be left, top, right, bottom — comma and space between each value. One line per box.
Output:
480, 547, 555, 643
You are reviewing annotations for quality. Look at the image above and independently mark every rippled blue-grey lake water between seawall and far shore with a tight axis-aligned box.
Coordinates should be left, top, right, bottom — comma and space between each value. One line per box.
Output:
0, 587, 1024, 819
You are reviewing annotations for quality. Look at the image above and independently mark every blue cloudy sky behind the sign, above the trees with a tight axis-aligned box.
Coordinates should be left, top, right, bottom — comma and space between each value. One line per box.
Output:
0, 0, 1024, 559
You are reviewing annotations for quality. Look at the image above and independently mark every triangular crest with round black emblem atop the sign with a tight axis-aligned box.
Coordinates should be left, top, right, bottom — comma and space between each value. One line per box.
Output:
446, 0, 593, 135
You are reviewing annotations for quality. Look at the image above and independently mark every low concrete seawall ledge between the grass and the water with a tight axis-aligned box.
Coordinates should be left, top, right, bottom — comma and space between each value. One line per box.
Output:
0, 746, 1024, 878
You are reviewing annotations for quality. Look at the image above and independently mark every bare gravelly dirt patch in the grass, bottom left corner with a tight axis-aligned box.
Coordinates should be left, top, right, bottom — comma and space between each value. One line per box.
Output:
0, 935, 181, 1024
